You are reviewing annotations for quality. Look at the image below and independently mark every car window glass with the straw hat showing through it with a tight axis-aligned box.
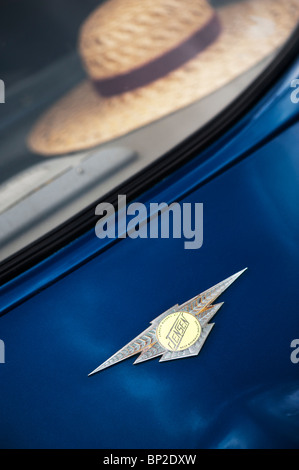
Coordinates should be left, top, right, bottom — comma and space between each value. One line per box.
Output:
0, 0, 299, 261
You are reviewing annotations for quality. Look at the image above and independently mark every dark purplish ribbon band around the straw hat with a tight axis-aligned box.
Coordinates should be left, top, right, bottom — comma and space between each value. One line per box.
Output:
93, 13, 221, 97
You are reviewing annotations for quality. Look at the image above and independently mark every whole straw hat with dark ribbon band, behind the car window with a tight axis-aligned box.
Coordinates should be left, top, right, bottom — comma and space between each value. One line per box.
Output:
28, 0, 299, 155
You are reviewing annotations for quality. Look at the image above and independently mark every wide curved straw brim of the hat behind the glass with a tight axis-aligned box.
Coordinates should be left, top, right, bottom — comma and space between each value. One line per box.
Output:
28, 0, 298, 156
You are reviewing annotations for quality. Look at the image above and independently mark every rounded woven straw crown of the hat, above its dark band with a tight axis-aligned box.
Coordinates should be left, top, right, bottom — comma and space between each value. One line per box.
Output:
79, 0, 214, 80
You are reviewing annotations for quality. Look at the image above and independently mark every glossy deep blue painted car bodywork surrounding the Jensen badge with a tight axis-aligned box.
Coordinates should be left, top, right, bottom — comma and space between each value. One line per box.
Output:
0, 60, 299, 448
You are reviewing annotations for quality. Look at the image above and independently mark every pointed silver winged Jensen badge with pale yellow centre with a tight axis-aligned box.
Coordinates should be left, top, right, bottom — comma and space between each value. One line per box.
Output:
89, 268, 247, 376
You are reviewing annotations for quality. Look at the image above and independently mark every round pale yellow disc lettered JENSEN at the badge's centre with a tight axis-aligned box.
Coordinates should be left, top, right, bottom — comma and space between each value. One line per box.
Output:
156, 312, 201, 351
